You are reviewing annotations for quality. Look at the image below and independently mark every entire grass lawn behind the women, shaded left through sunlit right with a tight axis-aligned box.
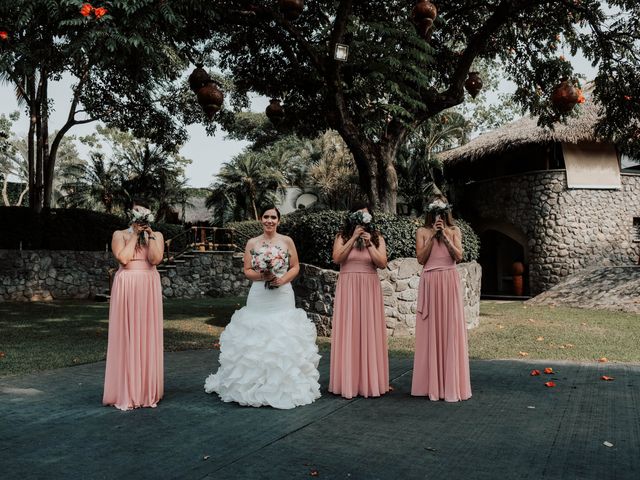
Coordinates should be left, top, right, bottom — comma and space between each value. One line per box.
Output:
0, 297, 640, 376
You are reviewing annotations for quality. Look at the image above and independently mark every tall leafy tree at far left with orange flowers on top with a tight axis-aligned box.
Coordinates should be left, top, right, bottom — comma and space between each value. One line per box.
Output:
0, 0, 210, 210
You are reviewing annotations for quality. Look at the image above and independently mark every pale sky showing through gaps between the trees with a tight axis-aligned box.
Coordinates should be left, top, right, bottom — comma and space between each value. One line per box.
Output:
0, 54, 595, 187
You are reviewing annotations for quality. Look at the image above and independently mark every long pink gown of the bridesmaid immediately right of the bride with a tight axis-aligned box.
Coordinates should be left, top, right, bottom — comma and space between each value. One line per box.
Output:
329, 247, 389, 398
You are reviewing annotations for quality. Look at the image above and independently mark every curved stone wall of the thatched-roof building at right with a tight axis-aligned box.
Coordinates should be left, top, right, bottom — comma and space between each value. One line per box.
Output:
454, 170, 640, 294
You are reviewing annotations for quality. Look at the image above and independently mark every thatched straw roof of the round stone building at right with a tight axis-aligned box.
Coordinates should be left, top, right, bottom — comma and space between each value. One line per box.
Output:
438, 89, 600, 164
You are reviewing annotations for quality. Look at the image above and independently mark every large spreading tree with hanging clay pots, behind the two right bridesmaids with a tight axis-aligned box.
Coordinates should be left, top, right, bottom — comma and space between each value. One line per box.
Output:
192, 0, 640, 211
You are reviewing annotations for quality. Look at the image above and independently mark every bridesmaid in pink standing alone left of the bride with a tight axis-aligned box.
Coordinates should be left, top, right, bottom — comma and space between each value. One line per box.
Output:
102, 203, 164, 410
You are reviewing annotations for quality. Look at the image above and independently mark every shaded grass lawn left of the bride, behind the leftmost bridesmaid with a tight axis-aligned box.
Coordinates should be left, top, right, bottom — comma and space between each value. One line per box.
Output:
0, 297, 245, 376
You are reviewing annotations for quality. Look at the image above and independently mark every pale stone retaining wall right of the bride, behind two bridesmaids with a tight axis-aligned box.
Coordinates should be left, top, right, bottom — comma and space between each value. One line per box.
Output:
293, 258, 482, 336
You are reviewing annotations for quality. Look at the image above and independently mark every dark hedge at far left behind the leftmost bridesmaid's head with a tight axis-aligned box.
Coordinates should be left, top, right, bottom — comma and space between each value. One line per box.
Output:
0, 207, 187, 251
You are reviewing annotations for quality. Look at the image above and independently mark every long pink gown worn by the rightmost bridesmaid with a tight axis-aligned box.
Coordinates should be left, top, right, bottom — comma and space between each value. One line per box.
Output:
411, 241, 471, 402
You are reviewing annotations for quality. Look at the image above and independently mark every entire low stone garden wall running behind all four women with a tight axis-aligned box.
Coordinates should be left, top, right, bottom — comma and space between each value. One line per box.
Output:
0, 250, 481, 336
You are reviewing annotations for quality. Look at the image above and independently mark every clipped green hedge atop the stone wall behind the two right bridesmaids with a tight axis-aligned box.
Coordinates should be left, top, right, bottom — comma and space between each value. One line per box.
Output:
227, 210, 480, 270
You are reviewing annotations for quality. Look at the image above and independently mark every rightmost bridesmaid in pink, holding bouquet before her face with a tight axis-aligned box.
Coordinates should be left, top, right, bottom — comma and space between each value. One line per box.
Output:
411, 196, 471, 402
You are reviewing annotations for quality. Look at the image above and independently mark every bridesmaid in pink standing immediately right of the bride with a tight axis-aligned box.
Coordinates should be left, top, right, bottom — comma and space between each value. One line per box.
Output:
329, 202, 389, 398
